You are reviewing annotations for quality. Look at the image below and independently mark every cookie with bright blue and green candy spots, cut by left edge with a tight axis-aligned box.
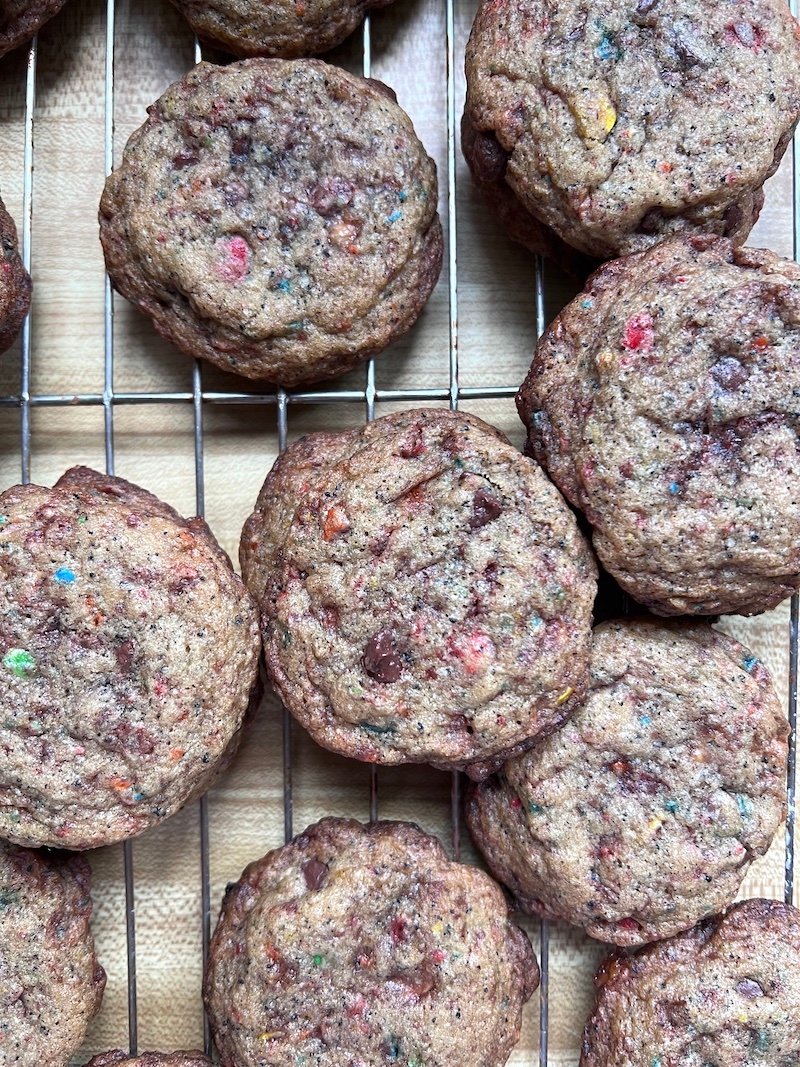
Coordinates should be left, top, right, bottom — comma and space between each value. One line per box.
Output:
0, 467, 259, 848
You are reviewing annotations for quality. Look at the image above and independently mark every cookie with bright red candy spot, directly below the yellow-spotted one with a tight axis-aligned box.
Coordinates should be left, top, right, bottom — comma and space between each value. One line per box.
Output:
517, 237, 800, 615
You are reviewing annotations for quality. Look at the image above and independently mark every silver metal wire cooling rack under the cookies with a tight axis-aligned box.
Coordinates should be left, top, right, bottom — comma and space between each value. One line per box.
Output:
0, 0, 800, 1067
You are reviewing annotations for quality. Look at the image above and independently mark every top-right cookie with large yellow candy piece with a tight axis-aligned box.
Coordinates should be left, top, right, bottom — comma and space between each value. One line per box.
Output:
464, 0, 800, 258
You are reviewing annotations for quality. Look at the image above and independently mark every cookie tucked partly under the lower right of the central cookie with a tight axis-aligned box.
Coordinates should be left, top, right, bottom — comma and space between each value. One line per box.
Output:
467, 621, 788, 945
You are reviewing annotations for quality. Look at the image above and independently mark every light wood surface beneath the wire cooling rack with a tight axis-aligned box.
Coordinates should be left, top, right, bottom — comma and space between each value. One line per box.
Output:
0, 0, 791, 1067
